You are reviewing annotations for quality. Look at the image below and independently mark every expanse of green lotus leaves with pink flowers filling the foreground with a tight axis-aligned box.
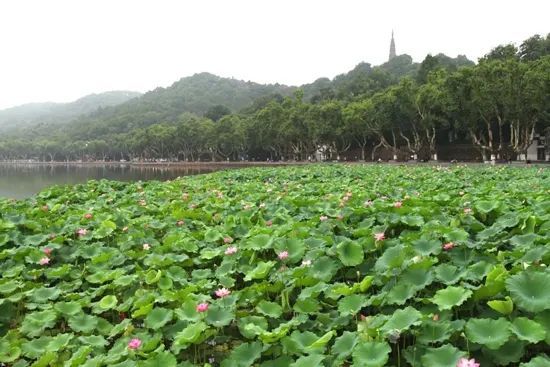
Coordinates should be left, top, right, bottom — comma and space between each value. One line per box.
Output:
0, 165, 550, 367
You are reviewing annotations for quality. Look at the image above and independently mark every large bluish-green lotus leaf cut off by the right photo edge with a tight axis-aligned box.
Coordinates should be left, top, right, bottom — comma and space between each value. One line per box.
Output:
506, 271, 550, 312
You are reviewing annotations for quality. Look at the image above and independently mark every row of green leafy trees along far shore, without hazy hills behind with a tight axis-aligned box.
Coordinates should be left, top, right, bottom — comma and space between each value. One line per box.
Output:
0, 36, 550, 161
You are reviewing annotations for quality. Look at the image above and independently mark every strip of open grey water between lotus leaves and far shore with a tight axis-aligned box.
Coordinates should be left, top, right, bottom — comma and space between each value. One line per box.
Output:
0, 164, 222, 199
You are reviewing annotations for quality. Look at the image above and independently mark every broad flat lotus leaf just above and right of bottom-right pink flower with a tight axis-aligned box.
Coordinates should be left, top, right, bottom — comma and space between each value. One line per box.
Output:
465, 318, 510, 349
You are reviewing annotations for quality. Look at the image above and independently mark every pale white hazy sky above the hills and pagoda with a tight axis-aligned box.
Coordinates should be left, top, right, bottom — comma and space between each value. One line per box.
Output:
0, 0, 550, 108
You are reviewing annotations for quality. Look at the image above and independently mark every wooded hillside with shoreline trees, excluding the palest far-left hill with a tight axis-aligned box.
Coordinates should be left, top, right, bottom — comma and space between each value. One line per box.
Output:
0, 36, 550, 160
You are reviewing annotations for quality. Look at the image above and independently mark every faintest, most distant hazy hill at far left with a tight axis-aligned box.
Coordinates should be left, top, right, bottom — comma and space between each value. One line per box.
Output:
0, 91, 141, 131
